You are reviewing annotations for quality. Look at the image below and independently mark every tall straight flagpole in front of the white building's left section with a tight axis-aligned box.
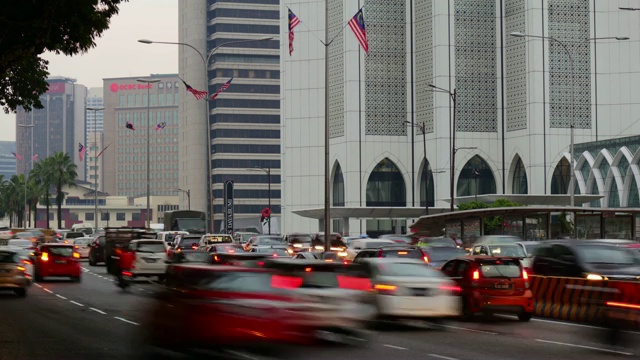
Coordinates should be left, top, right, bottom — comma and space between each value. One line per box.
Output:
324, 0, 331, 251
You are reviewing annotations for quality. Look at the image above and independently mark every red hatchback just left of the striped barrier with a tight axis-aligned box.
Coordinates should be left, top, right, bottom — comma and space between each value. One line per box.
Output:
442, 255, 534, 321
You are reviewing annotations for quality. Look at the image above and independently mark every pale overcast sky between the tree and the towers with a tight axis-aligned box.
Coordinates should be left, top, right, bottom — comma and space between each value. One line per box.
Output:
0, 0, 180, 141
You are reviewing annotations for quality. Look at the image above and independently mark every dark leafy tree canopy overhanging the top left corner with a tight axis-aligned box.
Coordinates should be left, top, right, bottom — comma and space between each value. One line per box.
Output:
0, 0, 128, 113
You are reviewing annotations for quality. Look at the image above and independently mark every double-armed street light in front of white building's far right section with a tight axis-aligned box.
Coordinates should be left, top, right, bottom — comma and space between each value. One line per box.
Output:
509, 33, 631, 208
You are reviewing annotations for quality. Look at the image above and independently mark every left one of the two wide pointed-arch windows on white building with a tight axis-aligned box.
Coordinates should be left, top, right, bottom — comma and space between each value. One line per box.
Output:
367, 158, 407, 207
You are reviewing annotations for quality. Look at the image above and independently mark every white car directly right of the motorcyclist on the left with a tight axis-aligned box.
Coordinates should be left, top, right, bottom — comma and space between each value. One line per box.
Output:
129, 239, 167, 278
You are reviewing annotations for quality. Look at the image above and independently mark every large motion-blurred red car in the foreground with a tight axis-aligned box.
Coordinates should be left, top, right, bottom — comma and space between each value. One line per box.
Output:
139, 264, 309, 356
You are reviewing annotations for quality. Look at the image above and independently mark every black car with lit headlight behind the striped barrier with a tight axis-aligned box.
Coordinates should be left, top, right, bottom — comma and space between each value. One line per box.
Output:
531, 240, 640, 281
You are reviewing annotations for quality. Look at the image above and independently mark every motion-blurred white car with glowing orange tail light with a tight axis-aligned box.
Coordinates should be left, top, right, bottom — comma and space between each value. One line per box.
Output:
363, 258, 462, 322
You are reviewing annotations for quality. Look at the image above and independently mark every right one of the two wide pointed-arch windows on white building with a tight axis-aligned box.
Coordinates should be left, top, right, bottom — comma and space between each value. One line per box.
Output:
456, 155, 496, 196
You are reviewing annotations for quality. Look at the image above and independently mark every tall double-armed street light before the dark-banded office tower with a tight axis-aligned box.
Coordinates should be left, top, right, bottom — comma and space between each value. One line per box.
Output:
138, 36, 273, 232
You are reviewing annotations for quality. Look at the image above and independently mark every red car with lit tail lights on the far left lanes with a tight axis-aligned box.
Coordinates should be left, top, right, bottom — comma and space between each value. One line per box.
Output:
33, 244, 82, 282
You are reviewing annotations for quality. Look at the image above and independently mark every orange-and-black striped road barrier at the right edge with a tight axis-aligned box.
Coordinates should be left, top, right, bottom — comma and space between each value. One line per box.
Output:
530, 275, 640, 329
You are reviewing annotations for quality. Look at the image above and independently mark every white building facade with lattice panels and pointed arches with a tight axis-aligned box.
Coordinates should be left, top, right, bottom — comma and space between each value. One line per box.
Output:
281, 0, 640, 233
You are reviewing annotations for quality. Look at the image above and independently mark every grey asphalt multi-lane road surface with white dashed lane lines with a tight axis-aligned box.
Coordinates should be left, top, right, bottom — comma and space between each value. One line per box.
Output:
0, 264, 640, 360
